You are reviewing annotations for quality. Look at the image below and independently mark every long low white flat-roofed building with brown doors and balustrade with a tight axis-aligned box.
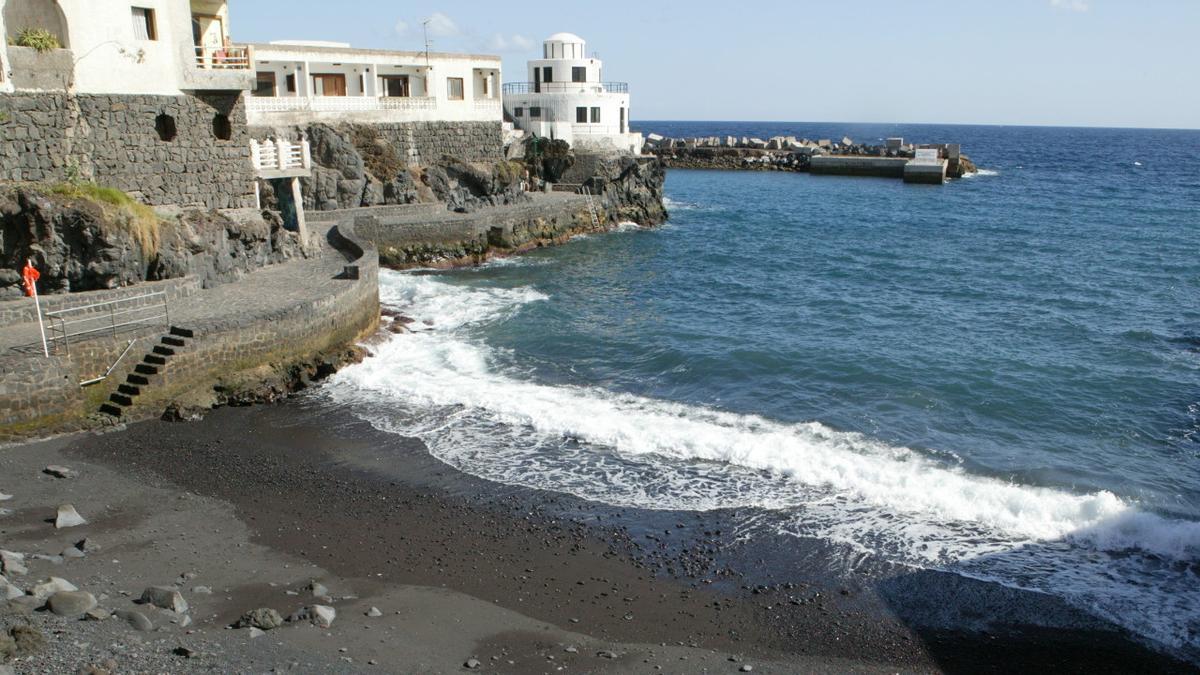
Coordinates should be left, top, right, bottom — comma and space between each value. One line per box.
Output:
246, 42, 503, 126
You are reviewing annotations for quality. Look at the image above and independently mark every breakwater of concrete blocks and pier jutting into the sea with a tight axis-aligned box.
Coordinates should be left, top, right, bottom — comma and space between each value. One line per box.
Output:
643, 133, 977, 184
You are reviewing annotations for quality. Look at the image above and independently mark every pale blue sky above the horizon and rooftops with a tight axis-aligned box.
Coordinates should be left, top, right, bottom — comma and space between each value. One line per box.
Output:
230, 0, 1200, 129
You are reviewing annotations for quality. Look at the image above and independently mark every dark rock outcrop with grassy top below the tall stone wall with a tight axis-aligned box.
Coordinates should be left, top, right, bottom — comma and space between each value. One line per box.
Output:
0, 185, 304, 299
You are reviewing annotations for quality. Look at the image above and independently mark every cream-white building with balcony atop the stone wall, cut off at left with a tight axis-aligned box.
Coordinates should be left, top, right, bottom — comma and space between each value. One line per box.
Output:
0, 0, 254, 96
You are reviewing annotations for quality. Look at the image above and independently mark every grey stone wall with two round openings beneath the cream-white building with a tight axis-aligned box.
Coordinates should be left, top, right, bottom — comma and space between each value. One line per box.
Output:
0, 94, 254, 209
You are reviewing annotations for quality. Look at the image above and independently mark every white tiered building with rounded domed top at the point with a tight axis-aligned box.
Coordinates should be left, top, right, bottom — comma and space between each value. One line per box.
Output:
504, 32, 642, 155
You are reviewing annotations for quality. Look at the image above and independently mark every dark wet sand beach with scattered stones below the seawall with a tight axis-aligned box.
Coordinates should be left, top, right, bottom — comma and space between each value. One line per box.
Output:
0, 393, 1189, 673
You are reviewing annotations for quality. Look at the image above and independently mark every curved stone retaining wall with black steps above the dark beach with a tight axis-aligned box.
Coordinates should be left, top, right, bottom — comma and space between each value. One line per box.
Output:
0, 223, 379, 441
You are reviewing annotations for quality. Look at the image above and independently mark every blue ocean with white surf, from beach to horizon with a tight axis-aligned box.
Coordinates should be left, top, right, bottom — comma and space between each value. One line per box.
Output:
324, 121, 1200, 658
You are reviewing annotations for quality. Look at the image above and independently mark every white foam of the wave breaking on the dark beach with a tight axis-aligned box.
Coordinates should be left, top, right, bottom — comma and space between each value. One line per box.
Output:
329, 267, 1200, 644
